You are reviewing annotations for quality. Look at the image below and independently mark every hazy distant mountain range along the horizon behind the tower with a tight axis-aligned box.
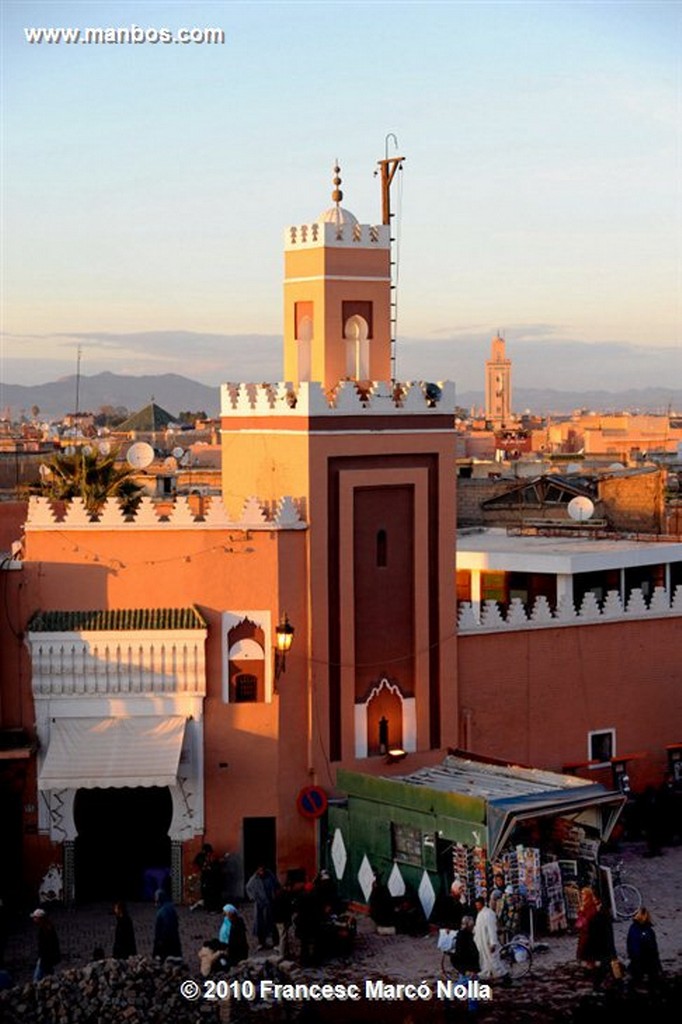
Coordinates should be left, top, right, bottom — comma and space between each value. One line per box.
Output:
0, 373, 682, 420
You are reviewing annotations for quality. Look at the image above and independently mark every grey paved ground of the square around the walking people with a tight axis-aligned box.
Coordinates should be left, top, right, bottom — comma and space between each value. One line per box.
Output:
0, 844, 682, 1024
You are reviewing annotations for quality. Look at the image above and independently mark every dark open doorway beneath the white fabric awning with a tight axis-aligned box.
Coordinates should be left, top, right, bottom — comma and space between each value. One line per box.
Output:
74, 786, 173, 903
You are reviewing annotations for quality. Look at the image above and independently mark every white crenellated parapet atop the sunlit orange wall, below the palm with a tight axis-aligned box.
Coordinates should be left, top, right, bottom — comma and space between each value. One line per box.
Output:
26, 495, 307, 532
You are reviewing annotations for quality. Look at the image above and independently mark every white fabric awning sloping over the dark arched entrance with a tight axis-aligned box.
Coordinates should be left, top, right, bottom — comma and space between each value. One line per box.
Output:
38, 715, 185, 790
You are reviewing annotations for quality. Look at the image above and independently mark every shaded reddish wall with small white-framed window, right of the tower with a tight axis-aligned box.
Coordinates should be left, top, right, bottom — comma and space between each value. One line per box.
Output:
458, 618, 682, 790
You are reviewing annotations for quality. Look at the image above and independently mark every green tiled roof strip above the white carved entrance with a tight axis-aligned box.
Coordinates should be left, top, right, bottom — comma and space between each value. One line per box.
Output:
27, 607, 207, 633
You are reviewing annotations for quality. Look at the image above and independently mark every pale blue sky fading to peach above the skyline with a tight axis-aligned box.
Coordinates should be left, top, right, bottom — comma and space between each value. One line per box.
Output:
0, 0, 682, 390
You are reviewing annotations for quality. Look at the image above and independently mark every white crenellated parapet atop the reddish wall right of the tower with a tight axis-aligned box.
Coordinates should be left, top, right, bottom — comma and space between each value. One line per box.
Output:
458, 587, 682, 636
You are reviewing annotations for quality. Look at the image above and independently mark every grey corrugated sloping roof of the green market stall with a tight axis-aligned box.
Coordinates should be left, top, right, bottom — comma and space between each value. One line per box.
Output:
384, 755, 626, 859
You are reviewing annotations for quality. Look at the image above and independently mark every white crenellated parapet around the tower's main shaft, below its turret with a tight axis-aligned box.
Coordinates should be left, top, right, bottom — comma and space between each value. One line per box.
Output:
220, 380, 456, 417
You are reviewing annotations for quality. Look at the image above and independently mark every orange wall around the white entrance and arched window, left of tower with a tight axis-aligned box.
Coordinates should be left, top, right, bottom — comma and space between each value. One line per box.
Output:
5, 528, 314, 884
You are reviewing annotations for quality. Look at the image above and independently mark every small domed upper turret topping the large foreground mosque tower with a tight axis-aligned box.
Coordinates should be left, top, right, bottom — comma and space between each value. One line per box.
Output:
284, 164, 391, 391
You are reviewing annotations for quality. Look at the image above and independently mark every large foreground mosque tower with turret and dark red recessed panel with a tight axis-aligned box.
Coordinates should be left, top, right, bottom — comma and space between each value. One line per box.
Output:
221, 160, 459, 784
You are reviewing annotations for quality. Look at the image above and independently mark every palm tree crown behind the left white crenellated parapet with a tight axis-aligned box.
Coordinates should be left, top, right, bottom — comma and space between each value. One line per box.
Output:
41, 445, 142, 513
